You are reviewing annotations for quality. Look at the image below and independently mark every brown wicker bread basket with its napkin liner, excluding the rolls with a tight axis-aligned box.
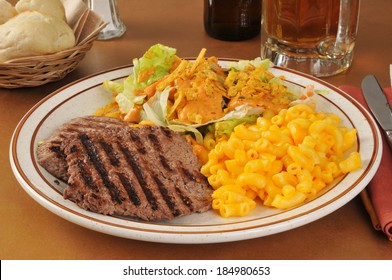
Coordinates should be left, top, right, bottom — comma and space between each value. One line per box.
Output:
0, 1, 106, 88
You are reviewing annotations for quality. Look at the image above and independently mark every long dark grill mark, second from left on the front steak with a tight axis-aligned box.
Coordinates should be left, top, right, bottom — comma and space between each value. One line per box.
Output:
79, 134, 122, 204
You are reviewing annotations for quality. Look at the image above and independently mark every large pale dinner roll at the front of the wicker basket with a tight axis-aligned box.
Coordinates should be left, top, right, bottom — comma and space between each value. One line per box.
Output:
0, 11, 75, 62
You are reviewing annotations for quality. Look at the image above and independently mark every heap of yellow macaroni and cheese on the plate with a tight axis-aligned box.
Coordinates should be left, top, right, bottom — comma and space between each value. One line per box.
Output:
201, 104, 361, 217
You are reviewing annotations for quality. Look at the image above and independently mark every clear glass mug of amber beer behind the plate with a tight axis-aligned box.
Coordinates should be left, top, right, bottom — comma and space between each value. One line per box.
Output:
261, 0, 360, 77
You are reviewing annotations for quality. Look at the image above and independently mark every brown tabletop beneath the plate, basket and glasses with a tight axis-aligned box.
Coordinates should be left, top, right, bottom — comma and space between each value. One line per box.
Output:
0, 0, 392, 260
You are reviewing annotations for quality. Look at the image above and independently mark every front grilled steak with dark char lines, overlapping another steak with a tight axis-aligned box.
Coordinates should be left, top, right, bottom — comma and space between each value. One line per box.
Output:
37, 117, 212, 220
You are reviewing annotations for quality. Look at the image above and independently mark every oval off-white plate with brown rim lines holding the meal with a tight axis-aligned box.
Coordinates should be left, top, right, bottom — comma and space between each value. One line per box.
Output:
10, 60, 382, 243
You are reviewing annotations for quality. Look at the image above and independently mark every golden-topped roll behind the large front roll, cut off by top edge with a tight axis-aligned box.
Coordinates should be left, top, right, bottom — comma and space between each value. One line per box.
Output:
15, 0, 66, 20
